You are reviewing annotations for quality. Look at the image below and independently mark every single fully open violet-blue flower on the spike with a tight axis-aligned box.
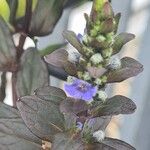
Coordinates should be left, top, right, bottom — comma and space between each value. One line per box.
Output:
64, 78, 97, 101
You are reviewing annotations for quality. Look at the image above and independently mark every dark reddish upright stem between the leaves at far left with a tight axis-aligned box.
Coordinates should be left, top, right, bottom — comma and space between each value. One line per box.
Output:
12, 0, 32, 107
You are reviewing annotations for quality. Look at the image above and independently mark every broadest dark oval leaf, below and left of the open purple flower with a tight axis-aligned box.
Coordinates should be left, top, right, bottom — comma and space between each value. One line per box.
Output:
17, 95, 64, 141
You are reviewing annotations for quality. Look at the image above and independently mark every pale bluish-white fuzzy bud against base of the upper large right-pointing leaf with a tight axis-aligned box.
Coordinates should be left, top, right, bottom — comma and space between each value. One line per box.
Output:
109, 58, 121, 70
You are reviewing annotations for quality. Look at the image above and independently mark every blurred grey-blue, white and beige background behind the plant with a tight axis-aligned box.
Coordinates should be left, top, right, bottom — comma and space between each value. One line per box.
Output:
3, 0, 150, 150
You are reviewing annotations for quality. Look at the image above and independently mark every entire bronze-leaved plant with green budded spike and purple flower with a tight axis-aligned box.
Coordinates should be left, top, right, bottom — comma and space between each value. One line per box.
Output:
0, 0, 143, 150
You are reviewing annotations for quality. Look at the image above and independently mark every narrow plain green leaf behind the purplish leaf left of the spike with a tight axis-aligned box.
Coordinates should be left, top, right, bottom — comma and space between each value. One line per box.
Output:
39, 43, 66, 56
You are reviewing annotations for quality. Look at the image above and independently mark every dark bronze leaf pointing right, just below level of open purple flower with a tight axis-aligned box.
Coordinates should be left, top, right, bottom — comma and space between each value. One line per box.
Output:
91, 95, 136, 117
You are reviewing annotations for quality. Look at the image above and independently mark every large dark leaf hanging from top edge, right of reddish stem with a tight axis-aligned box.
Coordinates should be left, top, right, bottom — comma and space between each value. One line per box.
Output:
30, 0, 65, 36
